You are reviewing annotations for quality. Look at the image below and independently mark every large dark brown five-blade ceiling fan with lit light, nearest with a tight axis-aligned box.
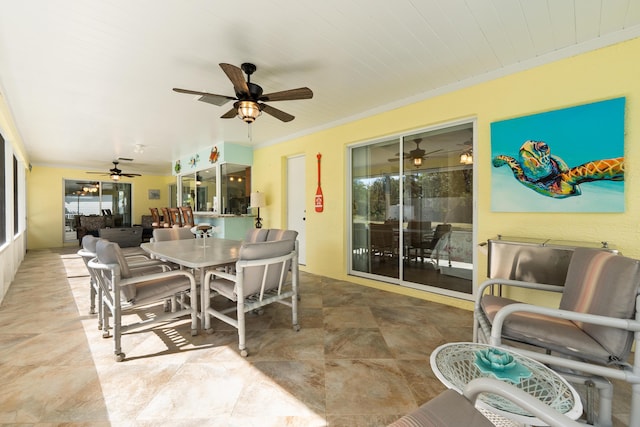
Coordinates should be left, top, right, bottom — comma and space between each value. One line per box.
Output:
173, 62, 313, 123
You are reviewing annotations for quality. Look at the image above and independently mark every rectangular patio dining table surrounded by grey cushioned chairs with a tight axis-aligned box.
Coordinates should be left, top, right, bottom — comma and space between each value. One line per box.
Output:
140, 237, 242, 330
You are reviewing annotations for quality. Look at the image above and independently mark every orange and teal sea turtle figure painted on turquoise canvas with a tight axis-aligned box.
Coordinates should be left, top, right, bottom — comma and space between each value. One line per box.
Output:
493, 140, 624, 199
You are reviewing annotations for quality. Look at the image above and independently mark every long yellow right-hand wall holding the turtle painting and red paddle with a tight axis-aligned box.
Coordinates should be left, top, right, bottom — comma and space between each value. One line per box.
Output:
253, 39, 640, 307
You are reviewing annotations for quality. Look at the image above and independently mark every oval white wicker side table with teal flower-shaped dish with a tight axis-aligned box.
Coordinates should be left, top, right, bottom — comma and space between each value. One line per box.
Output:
431, 342, 582, 426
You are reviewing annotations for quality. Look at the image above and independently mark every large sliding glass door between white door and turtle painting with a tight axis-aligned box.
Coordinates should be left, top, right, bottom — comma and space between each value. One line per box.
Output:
350, 123, 473, 294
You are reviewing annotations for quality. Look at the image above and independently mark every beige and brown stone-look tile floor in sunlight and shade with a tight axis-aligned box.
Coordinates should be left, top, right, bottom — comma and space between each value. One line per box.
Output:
0, 249, 628, 427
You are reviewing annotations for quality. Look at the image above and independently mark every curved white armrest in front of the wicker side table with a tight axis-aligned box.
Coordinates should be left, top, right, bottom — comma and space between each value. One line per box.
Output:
463, 378, 584, 427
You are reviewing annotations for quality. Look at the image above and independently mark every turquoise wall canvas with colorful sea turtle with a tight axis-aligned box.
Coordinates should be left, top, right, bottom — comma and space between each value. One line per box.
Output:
491, 98, 625, 212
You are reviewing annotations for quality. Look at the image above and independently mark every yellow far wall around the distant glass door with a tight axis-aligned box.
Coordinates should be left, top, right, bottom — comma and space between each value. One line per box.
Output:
27, 166, 175, 249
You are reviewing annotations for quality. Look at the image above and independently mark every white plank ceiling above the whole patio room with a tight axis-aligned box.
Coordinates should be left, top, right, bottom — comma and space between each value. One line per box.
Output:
0, 0, 640, 174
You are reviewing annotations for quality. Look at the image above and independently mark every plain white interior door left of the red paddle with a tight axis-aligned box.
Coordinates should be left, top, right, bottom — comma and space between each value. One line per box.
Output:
287, 156, 307, 265
